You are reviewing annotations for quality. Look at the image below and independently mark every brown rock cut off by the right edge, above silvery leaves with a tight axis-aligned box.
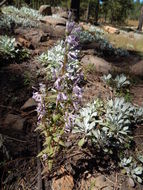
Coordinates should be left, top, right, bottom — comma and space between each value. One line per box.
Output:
130, 60, 143, 76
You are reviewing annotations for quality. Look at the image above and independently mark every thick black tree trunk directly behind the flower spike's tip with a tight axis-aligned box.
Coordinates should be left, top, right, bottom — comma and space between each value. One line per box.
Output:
71, 0, 80, 21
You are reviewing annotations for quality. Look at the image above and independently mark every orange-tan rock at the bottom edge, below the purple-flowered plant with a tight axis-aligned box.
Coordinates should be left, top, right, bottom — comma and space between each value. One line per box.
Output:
52, 168, 74, 190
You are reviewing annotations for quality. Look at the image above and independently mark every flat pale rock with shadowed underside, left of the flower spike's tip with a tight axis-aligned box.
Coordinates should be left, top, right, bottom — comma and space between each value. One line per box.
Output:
40, 16, 66, 26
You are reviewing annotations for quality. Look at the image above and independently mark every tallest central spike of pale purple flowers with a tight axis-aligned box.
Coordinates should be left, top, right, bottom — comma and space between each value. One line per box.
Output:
54, 13, 82, 130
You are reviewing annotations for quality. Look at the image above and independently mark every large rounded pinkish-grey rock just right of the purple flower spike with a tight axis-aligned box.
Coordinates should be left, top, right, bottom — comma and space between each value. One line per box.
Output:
81, 55, 112, 74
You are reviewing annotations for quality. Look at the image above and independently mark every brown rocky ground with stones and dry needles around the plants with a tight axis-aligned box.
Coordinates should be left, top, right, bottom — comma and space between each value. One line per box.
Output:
0, 5, 143, 190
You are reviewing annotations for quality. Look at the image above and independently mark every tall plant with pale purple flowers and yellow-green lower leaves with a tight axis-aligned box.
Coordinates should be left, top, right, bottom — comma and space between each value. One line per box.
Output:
33, 14, 83, 169
